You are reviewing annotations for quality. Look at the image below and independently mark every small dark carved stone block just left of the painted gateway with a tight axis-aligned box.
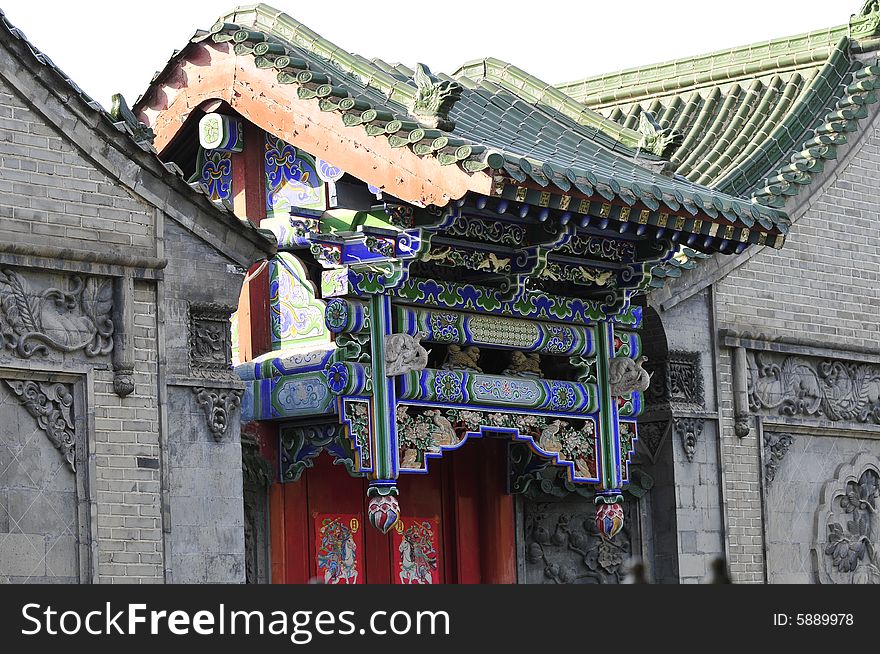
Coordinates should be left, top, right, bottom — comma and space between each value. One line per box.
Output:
189, 304, 237, 381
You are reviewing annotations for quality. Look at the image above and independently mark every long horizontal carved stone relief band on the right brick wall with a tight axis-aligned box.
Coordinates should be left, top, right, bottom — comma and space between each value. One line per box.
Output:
747, 351, 880, 424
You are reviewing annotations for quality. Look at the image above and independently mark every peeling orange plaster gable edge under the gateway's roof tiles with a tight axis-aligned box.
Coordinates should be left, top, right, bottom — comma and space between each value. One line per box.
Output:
137, 42, 492, 206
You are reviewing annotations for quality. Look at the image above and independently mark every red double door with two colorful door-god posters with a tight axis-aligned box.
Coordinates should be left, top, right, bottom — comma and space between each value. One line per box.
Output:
271, 439, 515, 585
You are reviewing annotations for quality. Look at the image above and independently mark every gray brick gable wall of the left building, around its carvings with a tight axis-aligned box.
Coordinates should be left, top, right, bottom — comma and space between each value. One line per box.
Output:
0, 41, 272, 583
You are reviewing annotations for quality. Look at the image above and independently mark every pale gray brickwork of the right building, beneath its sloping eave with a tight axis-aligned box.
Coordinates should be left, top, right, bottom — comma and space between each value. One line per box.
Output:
715, 122, 880, 582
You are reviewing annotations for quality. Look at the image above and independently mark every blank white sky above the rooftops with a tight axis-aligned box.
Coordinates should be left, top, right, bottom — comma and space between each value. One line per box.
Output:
0, 0, 862, 107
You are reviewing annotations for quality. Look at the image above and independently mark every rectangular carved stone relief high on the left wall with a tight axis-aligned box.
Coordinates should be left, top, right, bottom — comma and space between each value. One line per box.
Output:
0, 268, 113, 358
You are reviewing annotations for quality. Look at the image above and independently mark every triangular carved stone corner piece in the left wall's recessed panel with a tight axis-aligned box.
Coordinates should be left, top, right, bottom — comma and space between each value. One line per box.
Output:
3, 379, 76, 472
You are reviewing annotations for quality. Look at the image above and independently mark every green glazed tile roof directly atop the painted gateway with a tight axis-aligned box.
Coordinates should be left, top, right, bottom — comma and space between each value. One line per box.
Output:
175, 4, 789, 247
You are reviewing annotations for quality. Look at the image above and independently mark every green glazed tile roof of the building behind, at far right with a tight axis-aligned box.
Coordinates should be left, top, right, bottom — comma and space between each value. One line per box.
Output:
557, 4, 880, 207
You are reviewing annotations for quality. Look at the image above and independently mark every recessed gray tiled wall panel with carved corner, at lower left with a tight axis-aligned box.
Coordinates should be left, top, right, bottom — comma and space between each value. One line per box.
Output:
0, 371, 92, 583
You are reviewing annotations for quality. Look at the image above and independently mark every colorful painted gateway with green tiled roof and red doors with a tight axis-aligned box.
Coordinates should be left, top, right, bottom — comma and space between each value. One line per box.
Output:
134, 5, 789, 583
